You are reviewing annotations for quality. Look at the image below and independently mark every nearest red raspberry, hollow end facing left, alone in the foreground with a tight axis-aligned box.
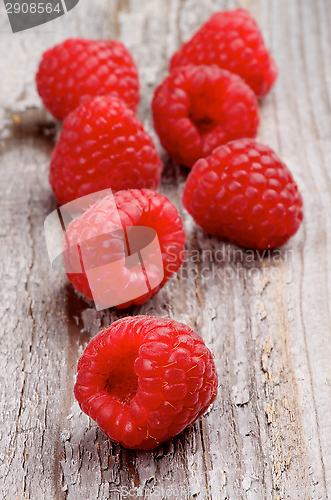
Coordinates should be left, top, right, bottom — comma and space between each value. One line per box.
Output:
74, 316, 218, 450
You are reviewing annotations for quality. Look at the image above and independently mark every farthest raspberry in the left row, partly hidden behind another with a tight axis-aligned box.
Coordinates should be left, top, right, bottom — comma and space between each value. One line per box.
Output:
36, 38, 139, 120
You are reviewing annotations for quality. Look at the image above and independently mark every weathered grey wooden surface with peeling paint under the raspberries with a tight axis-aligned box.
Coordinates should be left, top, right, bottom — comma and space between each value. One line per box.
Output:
0, 0, 331, 500
